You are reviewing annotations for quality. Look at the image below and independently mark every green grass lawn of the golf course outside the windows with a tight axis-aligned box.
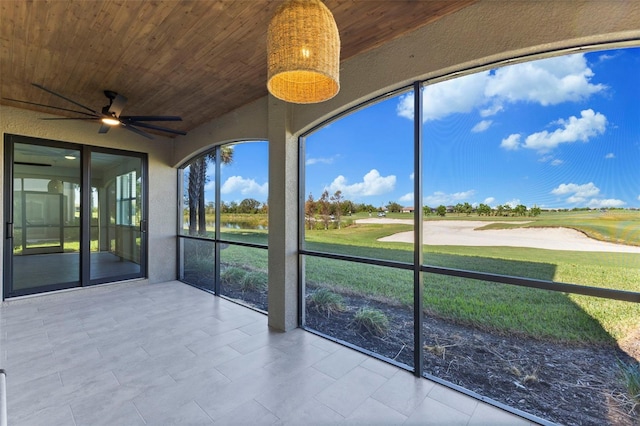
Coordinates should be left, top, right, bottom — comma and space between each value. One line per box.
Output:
205, 211, 640, 344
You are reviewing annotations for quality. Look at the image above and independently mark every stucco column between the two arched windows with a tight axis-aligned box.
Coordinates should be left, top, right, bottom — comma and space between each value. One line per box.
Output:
268, 96, 298, 331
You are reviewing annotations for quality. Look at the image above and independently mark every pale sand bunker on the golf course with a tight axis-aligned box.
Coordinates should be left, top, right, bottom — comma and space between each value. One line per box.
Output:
356, 218, 640, 254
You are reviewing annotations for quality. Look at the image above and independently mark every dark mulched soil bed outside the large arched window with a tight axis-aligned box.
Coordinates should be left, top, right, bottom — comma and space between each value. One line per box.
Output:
305, 296, 640, 426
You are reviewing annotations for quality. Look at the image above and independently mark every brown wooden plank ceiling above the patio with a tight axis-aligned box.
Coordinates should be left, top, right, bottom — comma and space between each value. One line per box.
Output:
0, 0, 475, 136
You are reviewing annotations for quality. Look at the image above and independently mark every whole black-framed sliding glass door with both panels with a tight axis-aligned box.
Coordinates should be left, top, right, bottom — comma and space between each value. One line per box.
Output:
3, 135, 146, 297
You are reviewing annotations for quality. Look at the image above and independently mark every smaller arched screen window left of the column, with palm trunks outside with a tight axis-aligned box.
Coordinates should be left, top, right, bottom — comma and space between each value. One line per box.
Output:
179, 141, 269, 311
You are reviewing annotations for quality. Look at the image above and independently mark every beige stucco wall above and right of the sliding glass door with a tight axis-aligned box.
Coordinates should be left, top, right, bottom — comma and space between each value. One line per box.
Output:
0, 105, 177, 298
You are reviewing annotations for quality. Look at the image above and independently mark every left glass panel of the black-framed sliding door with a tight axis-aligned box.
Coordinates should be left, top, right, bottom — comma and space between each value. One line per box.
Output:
12, 143, 80, 292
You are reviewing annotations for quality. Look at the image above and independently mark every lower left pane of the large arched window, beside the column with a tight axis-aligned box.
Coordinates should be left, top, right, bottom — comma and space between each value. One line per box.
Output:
304, 256, 414, 366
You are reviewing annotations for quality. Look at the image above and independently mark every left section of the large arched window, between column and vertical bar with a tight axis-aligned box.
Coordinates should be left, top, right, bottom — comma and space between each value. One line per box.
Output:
302, 90, 415, 368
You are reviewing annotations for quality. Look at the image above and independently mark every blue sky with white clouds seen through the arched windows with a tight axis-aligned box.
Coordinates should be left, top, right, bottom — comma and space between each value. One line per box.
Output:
207, 48, 640, 208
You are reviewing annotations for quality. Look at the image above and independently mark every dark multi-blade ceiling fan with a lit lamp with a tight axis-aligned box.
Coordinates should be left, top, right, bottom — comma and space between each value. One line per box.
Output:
5, 83, 187, 139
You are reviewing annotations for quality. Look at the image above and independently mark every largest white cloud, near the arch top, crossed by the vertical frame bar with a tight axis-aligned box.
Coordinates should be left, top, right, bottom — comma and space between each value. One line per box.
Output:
396, 54, 607, 122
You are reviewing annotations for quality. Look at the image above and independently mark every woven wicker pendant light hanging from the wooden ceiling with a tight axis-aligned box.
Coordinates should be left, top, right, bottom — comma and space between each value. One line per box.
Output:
267, 0, 340, 104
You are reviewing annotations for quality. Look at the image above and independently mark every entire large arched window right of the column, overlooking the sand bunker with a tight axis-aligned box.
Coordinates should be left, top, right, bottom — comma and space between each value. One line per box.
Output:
300, 48, 640, 424
